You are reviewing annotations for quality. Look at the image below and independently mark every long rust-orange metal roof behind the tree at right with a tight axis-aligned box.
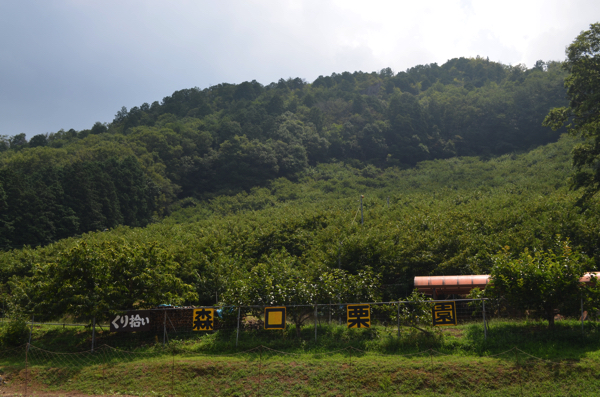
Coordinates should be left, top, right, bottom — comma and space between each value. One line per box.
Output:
415, 272, 600, 295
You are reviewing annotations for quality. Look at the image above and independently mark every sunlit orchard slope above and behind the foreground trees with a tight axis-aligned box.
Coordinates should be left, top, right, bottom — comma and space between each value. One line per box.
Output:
0, 137, 600, 310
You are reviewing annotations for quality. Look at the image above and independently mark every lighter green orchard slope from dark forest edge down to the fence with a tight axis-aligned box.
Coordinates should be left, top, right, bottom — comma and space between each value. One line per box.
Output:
0, 137, 600, 318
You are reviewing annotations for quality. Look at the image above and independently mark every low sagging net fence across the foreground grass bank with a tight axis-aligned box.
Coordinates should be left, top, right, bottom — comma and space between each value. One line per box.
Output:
0, 344, 598, 396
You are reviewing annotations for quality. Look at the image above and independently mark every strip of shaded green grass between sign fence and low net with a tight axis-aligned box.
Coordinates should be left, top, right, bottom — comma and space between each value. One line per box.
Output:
5, 319, 600, 360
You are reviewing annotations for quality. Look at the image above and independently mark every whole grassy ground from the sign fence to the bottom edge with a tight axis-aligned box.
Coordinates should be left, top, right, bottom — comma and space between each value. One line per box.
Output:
0, 320, 600, 396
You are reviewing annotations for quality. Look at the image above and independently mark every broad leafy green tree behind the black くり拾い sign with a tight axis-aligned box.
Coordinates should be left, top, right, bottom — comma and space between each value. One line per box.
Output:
16, 241, 197, 320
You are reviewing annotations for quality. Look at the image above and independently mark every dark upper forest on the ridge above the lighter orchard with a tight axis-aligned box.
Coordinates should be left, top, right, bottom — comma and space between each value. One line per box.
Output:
0, 58, 565, 249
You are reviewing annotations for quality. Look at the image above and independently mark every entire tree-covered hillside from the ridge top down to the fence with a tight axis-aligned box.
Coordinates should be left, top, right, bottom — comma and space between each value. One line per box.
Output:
0, 58, 600, 318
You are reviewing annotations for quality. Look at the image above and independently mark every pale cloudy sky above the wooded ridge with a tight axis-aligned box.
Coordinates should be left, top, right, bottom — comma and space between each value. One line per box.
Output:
0, 0, 600, 138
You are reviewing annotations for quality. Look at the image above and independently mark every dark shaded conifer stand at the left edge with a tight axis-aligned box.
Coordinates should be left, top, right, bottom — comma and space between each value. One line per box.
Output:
0, 157, 158, 249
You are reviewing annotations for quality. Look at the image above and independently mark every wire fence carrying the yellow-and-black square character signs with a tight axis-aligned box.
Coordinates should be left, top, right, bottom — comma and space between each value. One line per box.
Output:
10, 299, 591, 350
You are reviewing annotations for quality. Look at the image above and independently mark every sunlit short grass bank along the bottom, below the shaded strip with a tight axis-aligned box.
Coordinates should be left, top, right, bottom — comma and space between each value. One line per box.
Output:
10, 351, 600, 396
